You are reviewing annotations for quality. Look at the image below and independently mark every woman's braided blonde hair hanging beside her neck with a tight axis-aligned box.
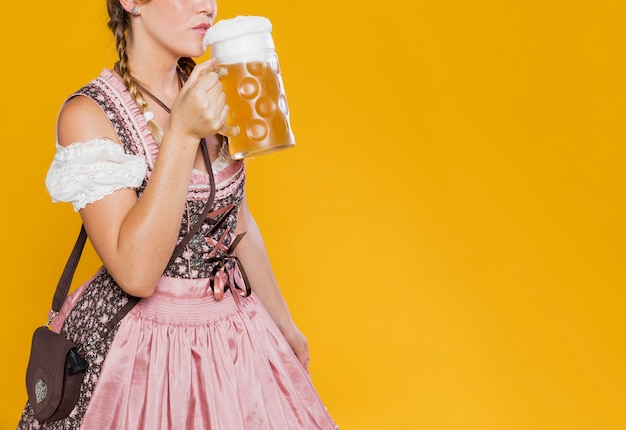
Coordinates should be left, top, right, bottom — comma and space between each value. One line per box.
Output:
107, 0, 196, 145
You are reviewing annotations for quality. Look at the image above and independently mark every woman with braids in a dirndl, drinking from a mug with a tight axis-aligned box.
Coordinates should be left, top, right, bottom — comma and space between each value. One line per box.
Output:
20, 0, 335, 430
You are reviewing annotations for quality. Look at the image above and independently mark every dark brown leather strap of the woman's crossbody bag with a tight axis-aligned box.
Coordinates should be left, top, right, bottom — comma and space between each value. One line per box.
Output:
52, 138, 214, 330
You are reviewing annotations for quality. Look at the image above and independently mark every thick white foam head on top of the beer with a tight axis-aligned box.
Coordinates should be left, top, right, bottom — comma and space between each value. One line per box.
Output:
203, 16, 274, 64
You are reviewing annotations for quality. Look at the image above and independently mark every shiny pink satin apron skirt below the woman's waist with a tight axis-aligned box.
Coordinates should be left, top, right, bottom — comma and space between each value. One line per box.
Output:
58, 277, 336, 430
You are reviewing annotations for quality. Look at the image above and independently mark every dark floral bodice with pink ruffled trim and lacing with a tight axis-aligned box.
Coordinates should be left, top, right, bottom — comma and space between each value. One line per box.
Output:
75, 70, 245, 278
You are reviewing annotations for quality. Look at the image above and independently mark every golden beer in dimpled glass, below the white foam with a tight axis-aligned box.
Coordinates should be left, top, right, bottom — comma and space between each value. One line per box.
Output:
219, 61, 295, 159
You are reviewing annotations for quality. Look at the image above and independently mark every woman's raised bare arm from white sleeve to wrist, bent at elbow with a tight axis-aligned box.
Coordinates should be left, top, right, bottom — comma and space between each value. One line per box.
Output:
83, 130, 197, 297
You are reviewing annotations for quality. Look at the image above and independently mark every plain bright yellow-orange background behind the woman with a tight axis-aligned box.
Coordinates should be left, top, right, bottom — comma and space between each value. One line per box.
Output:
0, 0, 626, 430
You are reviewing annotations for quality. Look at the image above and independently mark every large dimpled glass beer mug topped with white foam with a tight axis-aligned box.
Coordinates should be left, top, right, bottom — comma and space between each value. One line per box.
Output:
204, 16, 296, 159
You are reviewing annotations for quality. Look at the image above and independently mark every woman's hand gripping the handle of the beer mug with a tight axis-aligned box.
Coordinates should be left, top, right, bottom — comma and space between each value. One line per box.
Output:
170, 60, 228, 141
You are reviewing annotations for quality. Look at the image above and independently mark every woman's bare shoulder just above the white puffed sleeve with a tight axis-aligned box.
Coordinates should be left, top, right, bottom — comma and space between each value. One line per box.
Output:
57, 95, 119, 146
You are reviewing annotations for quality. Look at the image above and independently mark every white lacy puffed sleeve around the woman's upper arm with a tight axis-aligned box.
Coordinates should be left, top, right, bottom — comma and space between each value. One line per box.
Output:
46, 139, 147, 211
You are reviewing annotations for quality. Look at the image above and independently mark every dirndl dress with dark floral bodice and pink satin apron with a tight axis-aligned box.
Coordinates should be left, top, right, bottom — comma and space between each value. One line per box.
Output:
18, 70, 337, 430
